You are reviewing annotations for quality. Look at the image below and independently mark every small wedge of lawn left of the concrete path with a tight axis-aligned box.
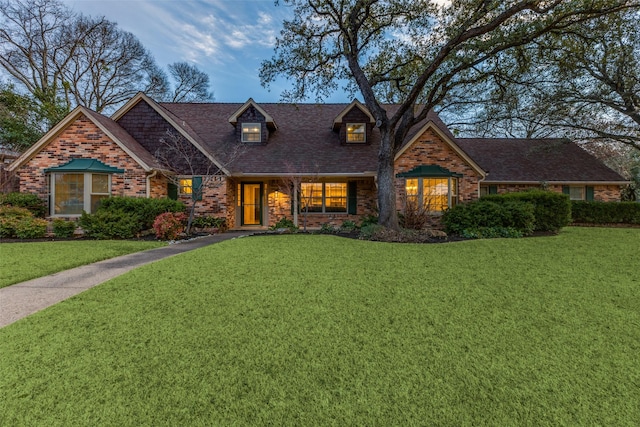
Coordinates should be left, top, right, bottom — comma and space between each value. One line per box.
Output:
0, 240, 166, 288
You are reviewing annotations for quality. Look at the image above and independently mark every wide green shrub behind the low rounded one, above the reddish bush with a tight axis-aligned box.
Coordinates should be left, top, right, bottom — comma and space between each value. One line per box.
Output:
97, 197, 185, 231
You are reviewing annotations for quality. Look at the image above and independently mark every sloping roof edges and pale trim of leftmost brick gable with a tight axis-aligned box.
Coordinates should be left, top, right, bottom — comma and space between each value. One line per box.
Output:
7, 106, 161, 171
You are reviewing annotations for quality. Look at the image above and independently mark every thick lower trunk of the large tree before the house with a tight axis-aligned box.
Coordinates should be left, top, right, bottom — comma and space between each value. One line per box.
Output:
378, 128, 400, 230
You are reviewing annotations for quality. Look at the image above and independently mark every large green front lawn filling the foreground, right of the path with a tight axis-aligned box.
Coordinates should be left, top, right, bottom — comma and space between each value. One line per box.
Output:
0, 228, 640, 426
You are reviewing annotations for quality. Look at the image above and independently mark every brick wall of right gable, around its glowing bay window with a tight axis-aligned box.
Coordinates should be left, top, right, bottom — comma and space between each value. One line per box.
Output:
395, 129, 480, 210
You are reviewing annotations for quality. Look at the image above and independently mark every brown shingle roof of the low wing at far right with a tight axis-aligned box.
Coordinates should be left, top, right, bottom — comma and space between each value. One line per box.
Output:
456, 138, 627, 184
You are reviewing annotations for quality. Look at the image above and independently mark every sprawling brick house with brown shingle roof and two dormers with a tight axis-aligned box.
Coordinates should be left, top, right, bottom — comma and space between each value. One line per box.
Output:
9, 93, 628, 229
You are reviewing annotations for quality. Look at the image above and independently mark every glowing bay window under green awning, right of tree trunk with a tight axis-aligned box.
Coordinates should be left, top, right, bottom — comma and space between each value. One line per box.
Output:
405, 177, 458, 212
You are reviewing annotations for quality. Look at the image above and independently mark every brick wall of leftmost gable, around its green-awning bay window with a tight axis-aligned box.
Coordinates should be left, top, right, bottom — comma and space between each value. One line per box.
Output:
18, 115, 147, 213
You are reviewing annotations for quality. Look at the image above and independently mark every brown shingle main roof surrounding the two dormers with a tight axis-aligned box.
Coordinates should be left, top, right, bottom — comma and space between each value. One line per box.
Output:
160, 103, 453, 176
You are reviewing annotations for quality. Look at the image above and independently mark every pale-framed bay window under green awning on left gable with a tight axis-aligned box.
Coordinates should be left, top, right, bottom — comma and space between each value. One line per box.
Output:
51, 173, 111, 216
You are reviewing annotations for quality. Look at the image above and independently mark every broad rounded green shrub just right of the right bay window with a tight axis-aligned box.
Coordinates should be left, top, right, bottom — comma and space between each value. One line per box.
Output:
442, 200, 535, 238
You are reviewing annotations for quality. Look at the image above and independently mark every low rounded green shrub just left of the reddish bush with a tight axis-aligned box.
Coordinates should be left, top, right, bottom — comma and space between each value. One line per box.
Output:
79, 209, 141, 239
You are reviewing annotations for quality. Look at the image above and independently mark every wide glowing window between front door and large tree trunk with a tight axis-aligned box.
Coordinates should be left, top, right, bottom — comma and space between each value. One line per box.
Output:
300, 182, 347, 213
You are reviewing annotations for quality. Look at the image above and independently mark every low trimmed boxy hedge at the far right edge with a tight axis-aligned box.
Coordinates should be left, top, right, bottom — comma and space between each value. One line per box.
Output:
571, 200, 640, 224
